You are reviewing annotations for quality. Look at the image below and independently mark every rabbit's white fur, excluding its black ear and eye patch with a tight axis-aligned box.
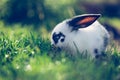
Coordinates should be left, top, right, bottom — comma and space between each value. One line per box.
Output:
51, 16, 109, 57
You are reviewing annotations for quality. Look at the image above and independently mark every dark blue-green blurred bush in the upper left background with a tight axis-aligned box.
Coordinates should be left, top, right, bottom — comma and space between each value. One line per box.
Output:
2, 0, 54, 24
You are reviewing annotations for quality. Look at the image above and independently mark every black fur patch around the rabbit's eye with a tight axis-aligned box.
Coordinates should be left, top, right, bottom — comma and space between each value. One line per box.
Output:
52, 32, 65, 44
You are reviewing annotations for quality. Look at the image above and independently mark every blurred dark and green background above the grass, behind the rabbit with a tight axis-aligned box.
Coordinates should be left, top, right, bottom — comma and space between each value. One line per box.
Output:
0, 0, 120, 42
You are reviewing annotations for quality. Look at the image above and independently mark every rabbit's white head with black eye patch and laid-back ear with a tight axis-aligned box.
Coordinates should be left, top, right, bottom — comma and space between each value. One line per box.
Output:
51, 14, 100, 48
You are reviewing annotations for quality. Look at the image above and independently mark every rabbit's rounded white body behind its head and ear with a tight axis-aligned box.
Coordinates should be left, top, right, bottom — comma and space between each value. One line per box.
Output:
70, 21, 109, 57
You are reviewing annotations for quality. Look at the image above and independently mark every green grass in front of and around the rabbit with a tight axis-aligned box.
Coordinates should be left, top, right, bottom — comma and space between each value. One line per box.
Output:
0, 22, 120, 80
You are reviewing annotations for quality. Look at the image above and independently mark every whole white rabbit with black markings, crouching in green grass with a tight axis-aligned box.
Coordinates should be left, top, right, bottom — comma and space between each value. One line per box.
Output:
51, 14, 110, 58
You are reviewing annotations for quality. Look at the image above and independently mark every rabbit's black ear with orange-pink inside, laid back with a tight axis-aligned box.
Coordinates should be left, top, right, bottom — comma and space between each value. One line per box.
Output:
68, 14, 100, 30
